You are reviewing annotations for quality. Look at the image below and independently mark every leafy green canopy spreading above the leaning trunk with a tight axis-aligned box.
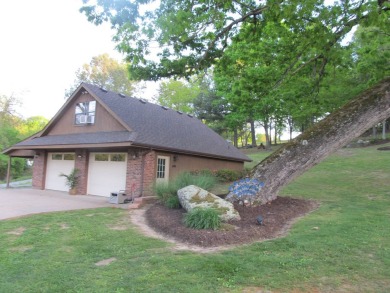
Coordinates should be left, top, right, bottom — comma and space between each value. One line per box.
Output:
81, 0, 390, 142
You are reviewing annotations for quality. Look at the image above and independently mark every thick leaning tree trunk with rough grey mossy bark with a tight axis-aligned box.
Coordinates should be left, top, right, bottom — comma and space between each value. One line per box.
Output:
251, 78, 390, 204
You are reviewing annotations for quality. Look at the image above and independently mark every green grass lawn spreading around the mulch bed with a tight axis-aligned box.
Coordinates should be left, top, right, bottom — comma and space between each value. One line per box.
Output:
0, 144, 390, 292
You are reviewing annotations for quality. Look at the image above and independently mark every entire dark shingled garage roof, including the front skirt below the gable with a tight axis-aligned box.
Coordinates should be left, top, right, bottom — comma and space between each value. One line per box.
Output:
5, 83, 250, 161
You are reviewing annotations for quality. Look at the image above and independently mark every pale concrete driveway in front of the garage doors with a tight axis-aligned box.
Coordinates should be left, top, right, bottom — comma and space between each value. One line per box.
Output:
0, 188, 128, 220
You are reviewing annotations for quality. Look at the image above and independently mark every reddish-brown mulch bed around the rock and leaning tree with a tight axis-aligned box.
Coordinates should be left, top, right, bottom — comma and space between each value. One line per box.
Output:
145, 197, 318, 247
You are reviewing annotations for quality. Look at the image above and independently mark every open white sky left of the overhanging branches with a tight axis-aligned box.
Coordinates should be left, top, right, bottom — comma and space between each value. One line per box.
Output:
0, 0, 155, 119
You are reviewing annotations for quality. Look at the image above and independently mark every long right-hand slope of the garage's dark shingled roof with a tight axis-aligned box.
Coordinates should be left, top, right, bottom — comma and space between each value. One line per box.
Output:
82, 83, 250, 161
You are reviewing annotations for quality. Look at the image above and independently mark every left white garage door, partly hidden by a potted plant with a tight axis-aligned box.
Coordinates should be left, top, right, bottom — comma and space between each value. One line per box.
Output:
45, 153, 75, 191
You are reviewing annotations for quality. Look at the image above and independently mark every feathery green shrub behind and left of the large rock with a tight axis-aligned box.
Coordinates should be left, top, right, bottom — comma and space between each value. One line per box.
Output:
154, 172, 216, 208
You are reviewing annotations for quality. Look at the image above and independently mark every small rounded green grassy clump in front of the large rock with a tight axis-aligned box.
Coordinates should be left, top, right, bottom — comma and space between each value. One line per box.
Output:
184, 208, 221, 230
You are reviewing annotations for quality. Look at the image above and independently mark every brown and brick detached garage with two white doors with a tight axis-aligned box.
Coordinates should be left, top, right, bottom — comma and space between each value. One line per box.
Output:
4, 83, 250, 197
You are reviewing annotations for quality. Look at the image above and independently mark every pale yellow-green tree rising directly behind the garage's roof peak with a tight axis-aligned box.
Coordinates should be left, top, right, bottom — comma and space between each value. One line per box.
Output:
65, 54, 137, 97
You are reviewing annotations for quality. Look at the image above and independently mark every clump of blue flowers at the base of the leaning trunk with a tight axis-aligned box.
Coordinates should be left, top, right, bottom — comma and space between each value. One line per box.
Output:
225, 178, 264, 205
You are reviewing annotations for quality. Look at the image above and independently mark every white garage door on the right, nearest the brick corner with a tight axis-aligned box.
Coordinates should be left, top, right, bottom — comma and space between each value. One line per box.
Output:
88, 153, 127, 197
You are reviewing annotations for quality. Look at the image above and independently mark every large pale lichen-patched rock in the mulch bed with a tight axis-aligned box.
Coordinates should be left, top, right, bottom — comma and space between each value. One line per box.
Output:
177, 185, 241, 221
